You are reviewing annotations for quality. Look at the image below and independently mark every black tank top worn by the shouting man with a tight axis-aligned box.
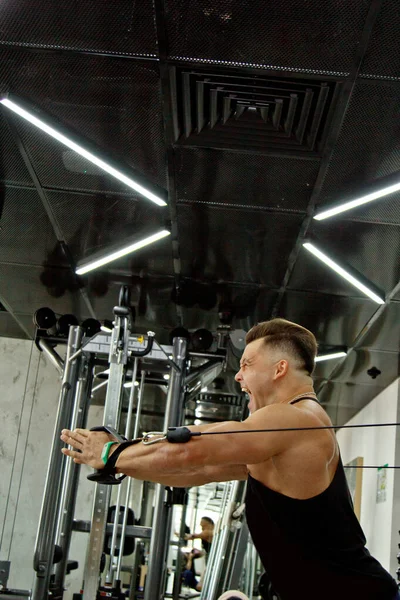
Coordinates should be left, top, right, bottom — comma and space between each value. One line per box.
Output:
246, 397, 397, 600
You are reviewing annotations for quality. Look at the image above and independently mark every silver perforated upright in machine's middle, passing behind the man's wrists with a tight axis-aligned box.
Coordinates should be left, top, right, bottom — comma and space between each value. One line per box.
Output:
82, 314, 129, 600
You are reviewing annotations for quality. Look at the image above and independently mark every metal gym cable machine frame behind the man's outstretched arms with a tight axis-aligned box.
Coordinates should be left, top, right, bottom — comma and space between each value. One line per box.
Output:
24, 288, 225, 600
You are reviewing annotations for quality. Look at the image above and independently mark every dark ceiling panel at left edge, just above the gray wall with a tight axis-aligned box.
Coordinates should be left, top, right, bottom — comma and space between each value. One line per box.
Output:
0, 263, 87, 315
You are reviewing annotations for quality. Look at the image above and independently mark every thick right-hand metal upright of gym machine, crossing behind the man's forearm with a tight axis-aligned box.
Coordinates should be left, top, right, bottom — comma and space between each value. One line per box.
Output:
144, 338, 187, 600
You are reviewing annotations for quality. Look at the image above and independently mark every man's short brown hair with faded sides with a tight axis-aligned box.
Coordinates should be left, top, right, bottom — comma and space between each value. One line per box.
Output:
246, 319, 318, 375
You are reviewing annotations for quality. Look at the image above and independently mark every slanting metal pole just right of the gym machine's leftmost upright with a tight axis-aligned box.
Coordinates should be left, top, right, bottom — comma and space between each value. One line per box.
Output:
54, 353, 93, 591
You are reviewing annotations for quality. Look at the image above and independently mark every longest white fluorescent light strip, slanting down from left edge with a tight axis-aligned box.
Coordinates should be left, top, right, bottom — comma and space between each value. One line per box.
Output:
0, 98, 167, 206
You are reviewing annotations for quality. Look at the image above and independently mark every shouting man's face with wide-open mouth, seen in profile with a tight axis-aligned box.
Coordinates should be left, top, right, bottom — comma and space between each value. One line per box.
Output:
235, 338, 276, 413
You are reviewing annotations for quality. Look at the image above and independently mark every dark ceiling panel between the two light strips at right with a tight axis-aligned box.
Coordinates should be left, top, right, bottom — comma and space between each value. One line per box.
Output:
310, 216, 400, 295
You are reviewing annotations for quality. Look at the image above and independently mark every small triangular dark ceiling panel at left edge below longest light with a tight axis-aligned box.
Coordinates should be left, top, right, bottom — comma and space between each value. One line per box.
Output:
0, 110, 33, 187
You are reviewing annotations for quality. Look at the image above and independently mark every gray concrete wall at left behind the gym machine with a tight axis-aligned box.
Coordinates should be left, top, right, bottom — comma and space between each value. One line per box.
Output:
0, 338, 103, 599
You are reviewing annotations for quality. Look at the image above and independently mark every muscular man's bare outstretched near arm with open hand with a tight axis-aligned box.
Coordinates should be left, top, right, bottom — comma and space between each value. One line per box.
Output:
61, 404, 326, 483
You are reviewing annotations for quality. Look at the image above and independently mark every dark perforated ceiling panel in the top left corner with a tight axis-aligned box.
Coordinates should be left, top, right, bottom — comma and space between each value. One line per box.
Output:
0, 0, 157, 56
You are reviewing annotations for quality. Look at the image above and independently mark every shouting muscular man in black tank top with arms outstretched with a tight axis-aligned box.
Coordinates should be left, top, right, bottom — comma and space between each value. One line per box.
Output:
61, 319, 400, 600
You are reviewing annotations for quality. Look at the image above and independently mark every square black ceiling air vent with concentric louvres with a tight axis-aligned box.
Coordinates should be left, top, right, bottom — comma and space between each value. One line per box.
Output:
170, 67, 339, 155
